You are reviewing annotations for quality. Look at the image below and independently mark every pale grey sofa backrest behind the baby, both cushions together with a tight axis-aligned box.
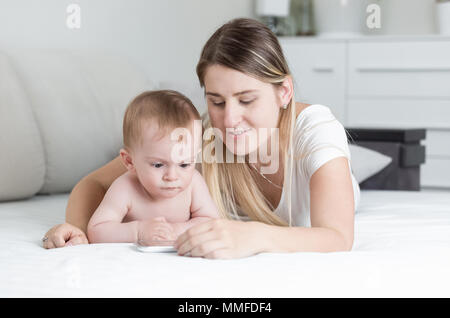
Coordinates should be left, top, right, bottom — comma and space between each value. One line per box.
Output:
0, 49, 155, 201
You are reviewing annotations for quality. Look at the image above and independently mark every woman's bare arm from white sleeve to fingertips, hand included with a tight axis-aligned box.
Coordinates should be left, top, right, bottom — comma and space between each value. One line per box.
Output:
175, 157, 354, 258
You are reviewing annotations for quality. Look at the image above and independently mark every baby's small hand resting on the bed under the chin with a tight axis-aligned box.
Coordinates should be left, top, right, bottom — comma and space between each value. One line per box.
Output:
138, 217, 176, 246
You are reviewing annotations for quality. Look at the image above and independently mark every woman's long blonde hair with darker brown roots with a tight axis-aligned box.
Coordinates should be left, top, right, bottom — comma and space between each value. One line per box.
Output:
197, 18, 296, 226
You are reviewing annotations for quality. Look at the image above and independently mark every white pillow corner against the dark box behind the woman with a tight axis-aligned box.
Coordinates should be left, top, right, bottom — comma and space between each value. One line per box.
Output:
348, 144, 392, 183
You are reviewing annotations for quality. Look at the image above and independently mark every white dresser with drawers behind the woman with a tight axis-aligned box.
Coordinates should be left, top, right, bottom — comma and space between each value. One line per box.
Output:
280, 35, 450, 188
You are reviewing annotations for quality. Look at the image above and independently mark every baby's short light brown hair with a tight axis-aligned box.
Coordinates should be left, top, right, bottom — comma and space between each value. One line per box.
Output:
123, 90, 201, 148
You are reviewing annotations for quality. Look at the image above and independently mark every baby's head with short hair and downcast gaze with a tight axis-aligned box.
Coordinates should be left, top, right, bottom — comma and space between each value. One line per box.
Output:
120, 90, 201, 198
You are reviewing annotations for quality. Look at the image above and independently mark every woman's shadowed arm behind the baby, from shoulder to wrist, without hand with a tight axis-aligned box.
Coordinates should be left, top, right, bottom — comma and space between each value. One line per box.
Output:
66, 157, 127, 233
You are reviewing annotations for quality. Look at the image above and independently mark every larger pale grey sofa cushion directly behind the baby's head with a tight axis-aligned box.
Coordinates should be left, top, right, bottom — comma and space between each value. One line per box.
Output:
5, 49, 154, 193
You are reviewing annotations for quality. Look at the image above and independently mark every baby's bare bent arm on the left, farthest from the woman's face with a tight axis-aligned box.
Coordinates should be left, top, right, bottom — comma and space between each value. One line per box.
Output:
87, 176, 139, 243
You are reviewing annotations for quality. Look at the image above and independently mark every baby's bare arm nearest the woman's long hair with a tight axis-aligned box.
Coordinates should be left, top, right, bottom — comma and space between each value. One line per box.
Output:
171, 170, 220, 237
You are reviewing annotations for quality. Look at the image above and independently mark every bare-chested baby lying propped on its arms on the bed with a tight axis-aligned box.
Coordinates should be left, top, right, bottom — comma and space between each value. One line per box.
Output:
87, 90, 220, 245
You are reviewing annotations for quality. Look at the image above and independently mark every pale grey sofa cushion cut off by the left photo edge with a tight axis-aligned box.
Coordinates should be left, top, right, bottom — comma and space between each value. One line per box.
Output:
0, 52, 45, 201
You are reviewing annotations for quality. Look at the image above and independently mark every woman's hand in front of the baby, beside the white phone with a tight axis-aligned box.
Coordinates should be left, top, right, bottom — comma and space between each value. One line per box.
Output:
174, 219, 265, 259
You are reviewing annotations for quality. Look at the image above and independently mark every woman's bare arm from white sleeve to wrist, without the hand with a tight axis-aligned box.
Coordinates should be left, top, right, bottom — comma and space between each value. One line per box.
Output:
262, 157, 355, 252
